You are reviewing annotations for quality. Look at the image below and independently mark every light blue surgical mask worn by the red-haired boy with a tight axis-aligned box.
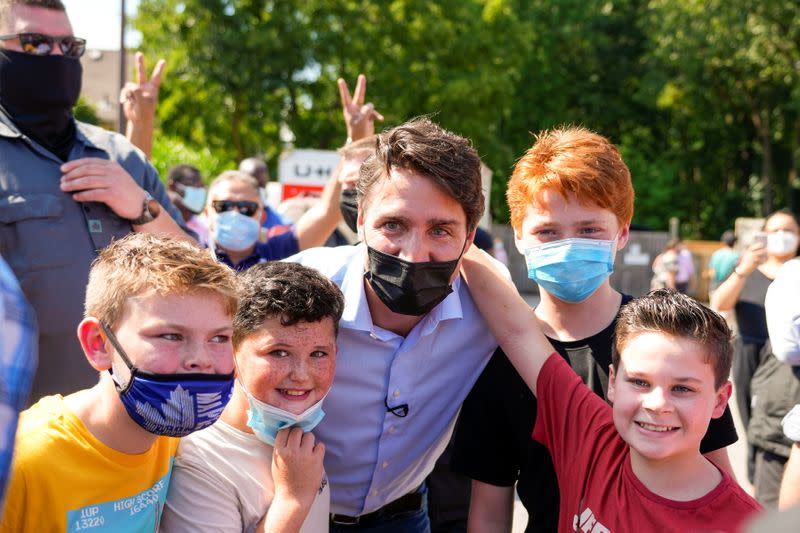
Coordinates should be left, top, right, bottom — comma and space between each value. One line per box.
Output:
525, 238, 616, 303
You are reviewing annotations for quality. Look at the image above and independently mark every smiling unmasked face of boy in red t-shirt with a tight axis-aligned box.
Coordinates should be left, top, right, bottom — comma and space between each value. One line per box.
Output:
608, 332, 731, 461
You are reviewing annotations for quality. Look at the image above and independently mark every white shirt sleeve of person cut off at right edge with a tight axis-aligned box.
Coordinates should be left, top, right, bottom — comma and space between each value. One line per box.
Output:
765, 259, 800, 366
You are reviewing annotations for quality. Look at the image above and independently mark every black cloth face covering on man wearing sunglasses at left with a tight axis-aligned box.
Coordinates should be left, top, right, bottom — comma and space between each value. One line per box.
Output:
0, 50, 83, 149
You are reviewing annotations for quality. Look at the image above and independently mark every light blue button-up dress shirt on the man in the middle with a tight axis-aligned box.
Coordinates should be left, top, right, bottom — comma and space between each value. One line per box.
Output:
288, 244, 500, 516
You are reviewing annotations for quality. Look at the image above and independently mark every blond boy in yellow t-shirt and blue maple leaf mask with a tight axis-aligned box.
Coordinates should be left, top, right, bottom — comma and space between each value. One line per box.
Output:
0, 233, 237, 532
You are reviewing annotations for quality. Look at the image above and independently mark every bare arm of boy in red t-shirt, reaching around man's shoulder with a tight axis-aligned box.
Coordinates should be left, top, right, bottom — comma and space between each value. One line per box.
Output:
461, 246, 553, 394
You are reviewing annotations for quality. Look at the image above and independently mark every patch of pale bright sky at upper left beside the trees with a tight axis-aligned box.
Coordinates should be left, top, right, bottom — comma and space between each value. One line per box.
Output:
62, 0, 141, 50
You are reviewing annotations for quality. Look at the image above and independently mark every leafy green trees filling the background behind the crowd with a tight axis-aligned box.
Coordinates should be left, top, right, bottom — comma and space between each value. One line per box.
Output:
136, 0, 800, 238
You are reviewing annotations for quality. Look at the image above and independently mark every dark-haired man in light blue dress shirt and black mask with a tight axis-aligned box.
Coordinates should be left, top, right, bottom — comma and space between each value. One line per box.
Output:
286, 118, 502, 532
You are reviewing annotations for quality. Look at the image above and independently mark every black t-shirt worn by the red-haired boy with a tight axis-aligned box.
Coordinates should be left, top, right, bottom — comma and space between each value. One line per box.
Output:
452, 295, 738, 532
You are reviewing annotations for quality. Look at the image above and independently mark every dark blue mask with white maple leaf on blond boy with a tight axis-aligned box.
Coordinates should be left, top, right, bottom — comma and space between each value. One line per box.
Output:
100, 322, 233, 437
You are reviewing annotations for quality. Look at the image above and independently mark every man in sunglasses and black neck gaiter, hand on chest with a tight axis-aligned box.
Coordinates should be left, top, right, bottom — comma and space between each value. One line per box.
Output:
0, 0, 189, 400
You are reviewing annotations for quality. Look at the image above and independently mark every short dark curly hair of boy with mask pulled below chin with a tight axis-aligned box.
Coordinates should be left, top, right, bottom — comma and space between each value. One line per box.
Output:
233, 261, 344, 348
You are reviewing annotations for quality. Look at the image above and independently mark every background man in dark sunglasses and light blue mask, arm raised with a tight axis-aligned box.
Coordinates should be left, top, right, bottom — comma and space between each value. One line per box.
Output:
205, 168, 342, 271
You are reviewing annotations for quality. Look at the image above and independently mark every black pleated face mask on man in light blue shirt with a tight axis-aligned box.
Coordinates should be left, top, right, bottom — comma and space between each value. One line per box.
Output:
364, 246, 463, 316
